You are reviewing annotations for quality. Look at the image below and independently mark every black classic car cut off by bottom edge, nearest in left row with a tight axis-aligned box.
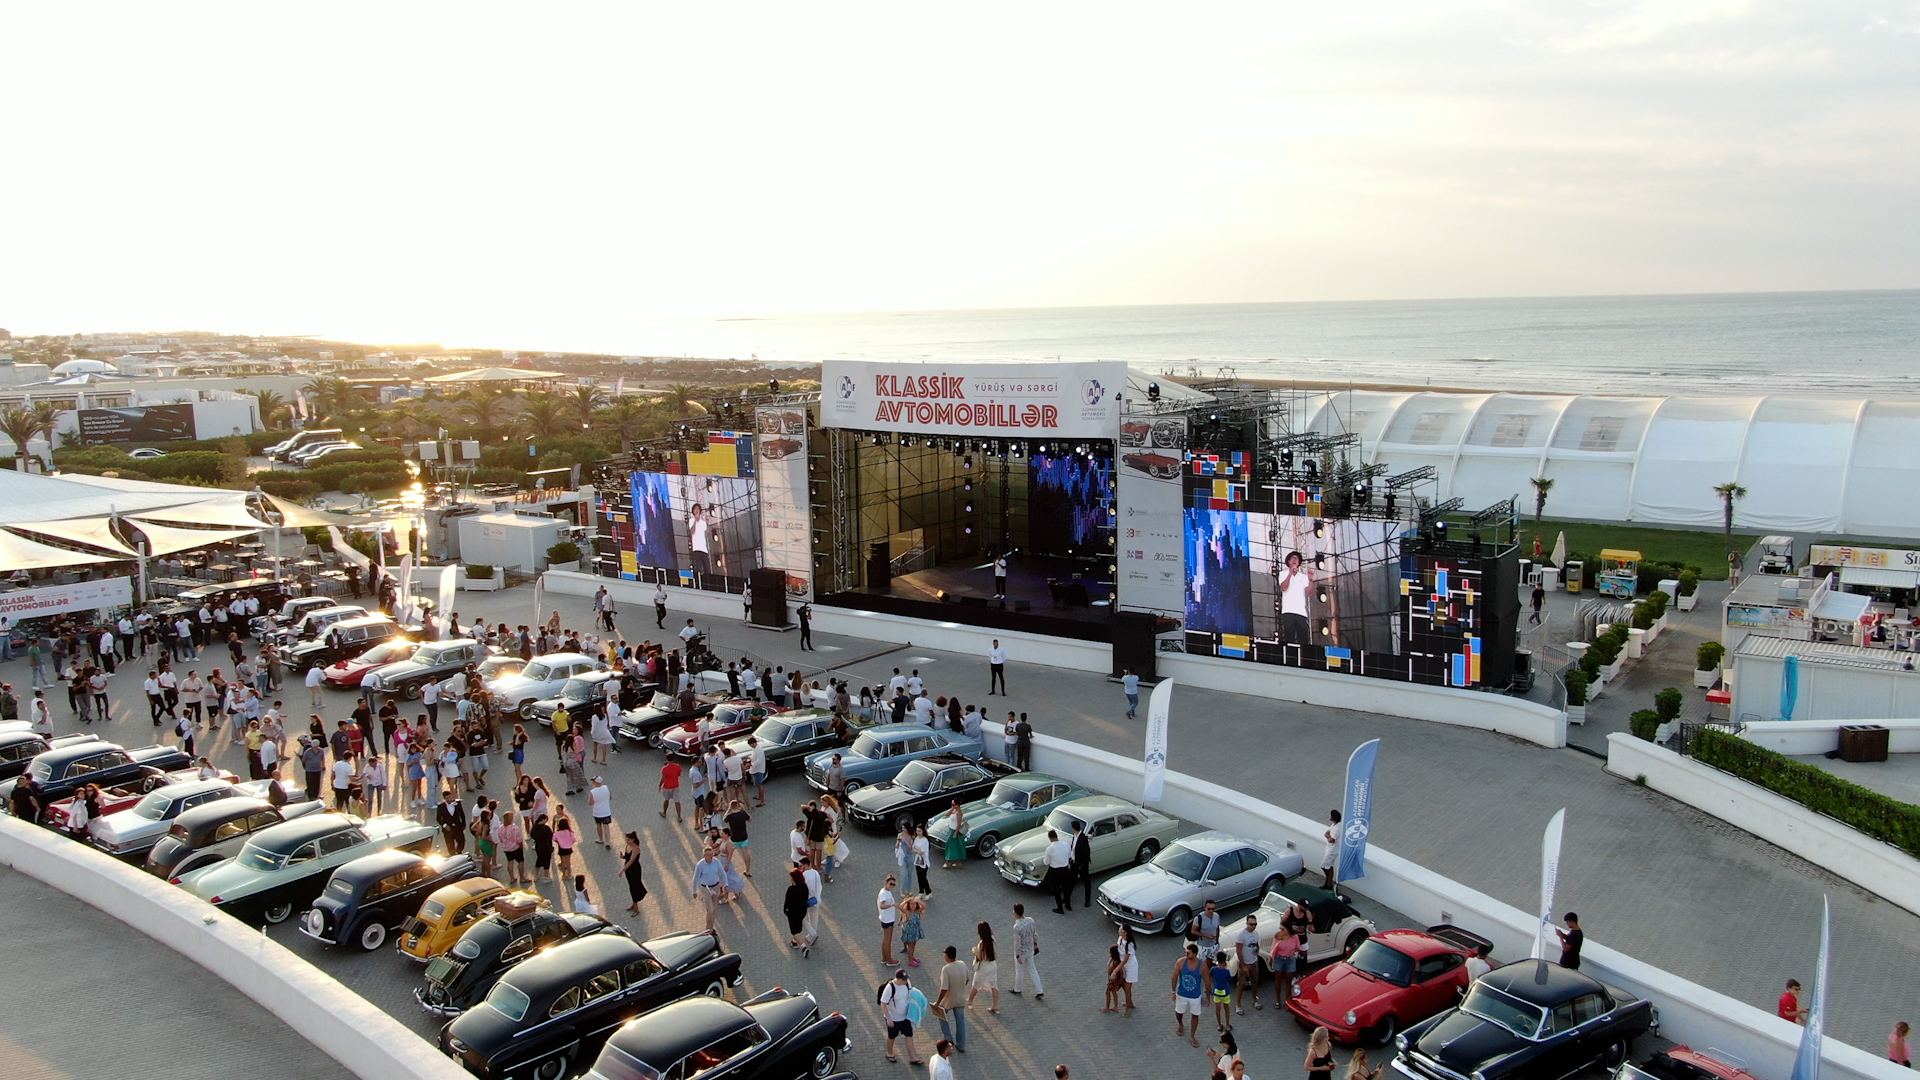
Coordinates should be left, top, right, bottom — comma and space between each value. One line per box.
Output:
586, 988, 852, 1080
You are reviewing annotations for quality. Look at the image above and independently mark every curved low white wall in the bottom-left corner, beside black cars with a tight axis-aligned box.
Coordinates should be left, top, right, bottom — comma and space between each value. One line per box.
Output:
0, 817, 467, 1080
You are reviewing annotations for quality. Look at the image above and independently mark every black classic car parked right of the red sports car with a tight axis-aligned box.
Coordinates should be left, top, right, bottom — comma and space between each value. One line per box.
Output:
1394, 961, 1659, 1080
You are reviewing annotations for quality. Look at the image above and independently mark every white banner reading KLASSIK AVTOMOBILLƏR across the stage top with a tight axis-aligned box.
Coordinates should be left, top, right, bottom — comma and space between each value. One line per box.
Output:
820, 359, 1127, 438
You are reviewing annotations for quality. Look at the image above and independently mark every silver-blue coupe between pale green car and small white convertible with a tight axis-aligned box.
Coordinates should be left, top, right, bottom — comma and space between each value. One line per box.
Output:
1098, 830, 1302, 934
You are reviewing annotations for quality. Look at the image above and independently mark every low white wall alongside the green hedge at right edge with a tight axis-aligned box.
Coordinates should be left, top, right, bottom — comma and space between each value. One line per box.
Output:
1607, 734, 1920, 913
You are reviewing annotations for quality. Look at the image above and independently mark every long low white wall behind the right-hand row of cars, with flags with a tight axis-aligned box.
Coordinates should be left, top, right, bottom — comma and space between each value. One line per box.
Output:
1033, 734, 1912, 1080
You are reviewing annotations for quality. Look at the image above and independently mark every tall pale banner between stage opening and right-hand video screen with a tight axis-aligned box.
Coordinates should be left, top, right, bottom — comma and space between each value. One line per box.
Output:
1114, 415, 1187, 617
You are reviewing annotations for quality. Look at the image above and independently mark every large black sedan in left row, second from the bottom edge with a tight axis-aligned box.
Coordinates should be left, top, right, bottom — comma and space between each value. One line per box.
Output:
440, 930, 741, 1080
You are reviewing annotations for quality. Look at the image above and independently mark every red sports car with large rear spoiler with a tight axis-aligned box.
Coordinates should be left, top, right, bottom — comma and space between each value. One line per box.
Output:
1282, 914, 1488, 1043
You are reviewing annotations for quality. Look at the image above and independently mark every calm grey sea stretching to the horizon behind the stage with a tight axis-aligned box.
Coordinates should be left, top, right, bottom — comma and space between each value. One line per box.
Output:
614, 290, 1920, 398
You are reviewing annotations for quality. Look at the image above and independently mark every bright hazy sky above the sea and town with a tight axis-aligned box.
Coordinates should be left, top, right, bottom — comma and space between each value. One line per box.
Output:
0, 0, 1920, 350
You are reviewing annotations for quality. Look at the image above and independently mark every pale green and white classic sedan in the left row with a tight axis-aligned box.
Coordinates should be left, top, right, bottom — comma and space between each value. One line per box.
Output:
180, 813, 440, 922
